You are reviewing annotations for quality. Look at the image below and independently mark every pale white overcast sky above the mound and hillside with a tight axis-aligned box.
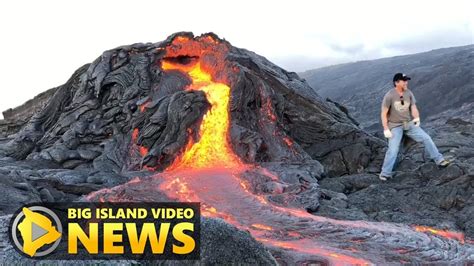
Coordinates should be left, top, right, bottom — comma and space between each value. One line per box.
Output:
0, 0, 474, 118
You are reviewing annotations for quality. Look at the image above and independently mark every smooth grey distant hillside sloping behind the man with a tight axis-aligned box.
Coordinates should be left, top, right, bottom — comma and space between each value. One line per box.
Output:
300, 45, 474, 130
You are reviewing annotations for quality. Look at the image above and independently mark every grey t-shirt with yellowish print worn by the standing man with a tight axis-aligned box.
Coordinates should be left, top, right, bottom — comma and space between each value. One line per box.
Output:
382, 89, 416, 129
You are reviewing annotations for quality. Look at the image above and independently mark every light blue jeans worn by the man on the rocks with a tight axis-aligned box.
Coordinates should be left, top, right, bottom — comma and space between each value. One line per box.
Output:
380, 122, 444, 177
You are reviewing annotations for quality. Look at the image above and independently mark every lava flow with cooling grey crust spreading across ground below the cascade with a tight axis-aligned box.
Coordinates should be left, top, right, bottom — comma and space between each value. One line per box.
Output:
157, 166, 468, 265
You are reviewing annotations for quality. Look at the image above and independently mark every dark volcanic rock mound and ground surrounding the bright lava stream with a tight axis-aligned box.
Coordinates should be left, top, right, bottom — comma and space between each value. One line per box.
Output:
0, 33, 474, 264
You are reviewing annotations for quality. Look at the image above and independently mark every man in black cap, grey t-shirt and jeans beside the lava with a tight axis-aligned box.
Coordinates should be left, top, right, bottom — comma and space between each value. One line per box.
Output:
379, 73, 449, 181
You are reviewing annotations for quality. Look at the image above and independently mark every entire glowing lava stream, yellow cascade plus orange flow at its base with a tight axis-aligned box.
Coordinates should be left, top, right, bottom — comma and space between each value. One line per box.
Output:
160, 61, 368, 264
